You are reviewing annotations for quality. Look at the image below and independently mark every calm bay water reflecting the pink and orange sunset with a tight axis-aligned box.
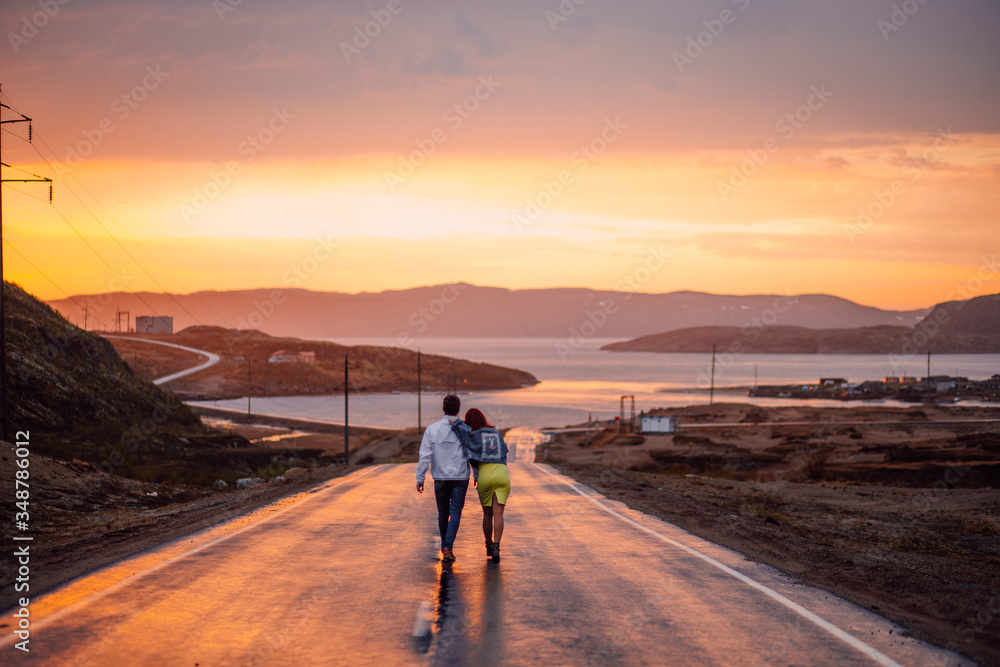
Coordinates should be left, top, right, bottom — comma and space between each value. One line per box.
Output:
194, 338, 1000, 429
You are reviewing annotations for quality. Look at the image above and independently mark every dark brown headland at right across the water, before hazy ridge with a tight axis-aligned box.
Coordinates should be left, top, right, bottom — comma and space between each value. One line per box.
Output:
601, 295, 1000, 354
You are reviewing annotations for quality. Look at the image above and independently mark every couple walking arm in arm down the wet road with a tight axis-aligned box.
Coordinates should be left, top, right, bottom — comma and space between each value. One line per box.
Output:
417, 394, 510, 563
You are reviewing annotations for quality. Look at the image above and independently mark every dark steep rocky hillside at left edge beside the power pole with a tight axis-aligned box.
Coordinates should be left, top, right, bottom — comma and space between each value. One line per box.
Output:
0, 283, 311, 486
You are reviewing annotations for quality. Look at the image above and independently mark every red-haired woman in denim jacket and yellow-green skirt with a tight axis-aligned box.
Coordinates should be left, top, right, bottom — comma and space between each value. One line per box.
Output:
451, 408, 510, 563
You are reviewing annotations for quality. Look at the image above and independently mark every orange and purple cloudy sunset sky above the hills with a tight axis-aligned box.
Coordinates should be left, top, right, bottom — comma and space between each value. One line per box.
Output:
0, 0, 1000, 309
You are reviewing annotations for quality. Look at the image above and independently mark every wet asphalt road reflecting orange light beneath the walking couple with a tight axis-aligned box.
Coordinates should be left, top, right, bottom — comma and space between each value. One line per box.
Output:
0, 462, 963, 666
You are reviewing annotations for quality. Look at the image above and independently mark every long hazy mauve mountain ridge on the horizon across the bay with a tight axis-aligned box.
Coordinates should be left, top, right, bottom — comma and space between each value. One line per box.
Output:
49, 283, 928, 339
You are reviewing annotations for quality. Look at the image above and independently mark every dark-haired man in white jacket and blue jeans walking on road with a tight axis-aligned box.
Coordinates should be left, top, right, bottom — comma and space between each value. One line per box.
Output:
417, 394, 469, 562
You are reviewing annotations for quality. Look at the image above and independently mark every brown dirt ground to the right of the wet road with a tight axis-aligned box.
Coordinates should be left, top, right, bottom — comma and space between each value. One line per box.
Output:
539, 405, 1000, 665
